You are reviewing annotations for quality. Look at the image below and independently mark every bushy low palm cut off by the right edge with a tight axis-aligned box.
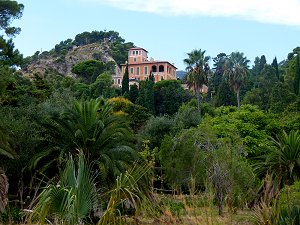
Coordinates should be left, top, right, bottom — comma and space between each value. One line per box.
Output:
255, 131, 300, 186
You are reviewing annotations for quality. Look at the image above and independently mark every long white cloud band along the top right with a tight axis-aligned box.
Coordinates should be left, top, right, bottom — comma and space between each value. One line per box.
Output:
81, 0, 300, 26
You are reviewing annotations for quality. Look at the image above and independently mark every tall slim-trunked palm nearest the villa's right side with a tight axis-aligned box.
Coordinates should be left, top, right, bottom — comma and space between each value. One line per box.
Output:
183, 49, 210, 118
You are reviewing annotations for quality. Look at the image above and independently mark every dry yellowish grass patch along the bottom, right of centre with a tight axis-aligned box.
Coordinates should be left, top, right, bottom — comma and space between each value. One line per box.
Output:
126, 193, 254, 225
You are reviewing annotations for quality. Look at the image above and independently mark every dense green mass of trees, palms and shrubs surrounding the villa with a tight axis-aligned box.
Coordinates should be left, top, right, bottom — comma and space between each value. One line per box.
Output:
0, 1, 300, 224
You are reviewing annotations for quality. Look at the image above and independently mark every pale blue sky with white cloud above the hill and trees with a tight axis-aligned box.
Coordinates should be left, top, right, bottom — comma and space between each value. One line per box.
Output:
13, 0, 300, 70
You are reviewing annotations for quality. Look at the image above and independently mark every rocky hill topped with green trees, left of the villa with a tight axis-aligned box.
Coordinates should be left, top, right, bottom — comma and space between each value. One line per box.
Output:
21, 31, 133, 77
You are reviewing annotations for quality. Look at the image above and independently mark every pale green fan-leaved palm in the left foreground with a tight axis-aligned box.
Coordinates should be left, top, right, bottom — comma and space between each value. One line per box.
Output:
28, 153, 98, 225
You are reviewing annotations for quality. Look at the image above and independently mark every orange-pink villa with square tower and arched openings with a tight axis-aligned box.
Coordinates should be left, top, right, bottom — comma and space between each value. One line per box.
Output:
114, 47, 177, 86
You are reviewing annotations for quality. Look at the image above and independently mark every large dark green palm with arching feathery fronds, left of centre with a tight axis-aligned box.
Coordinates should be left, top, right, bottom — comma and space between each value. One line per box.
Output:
34, 99, 135, 185
